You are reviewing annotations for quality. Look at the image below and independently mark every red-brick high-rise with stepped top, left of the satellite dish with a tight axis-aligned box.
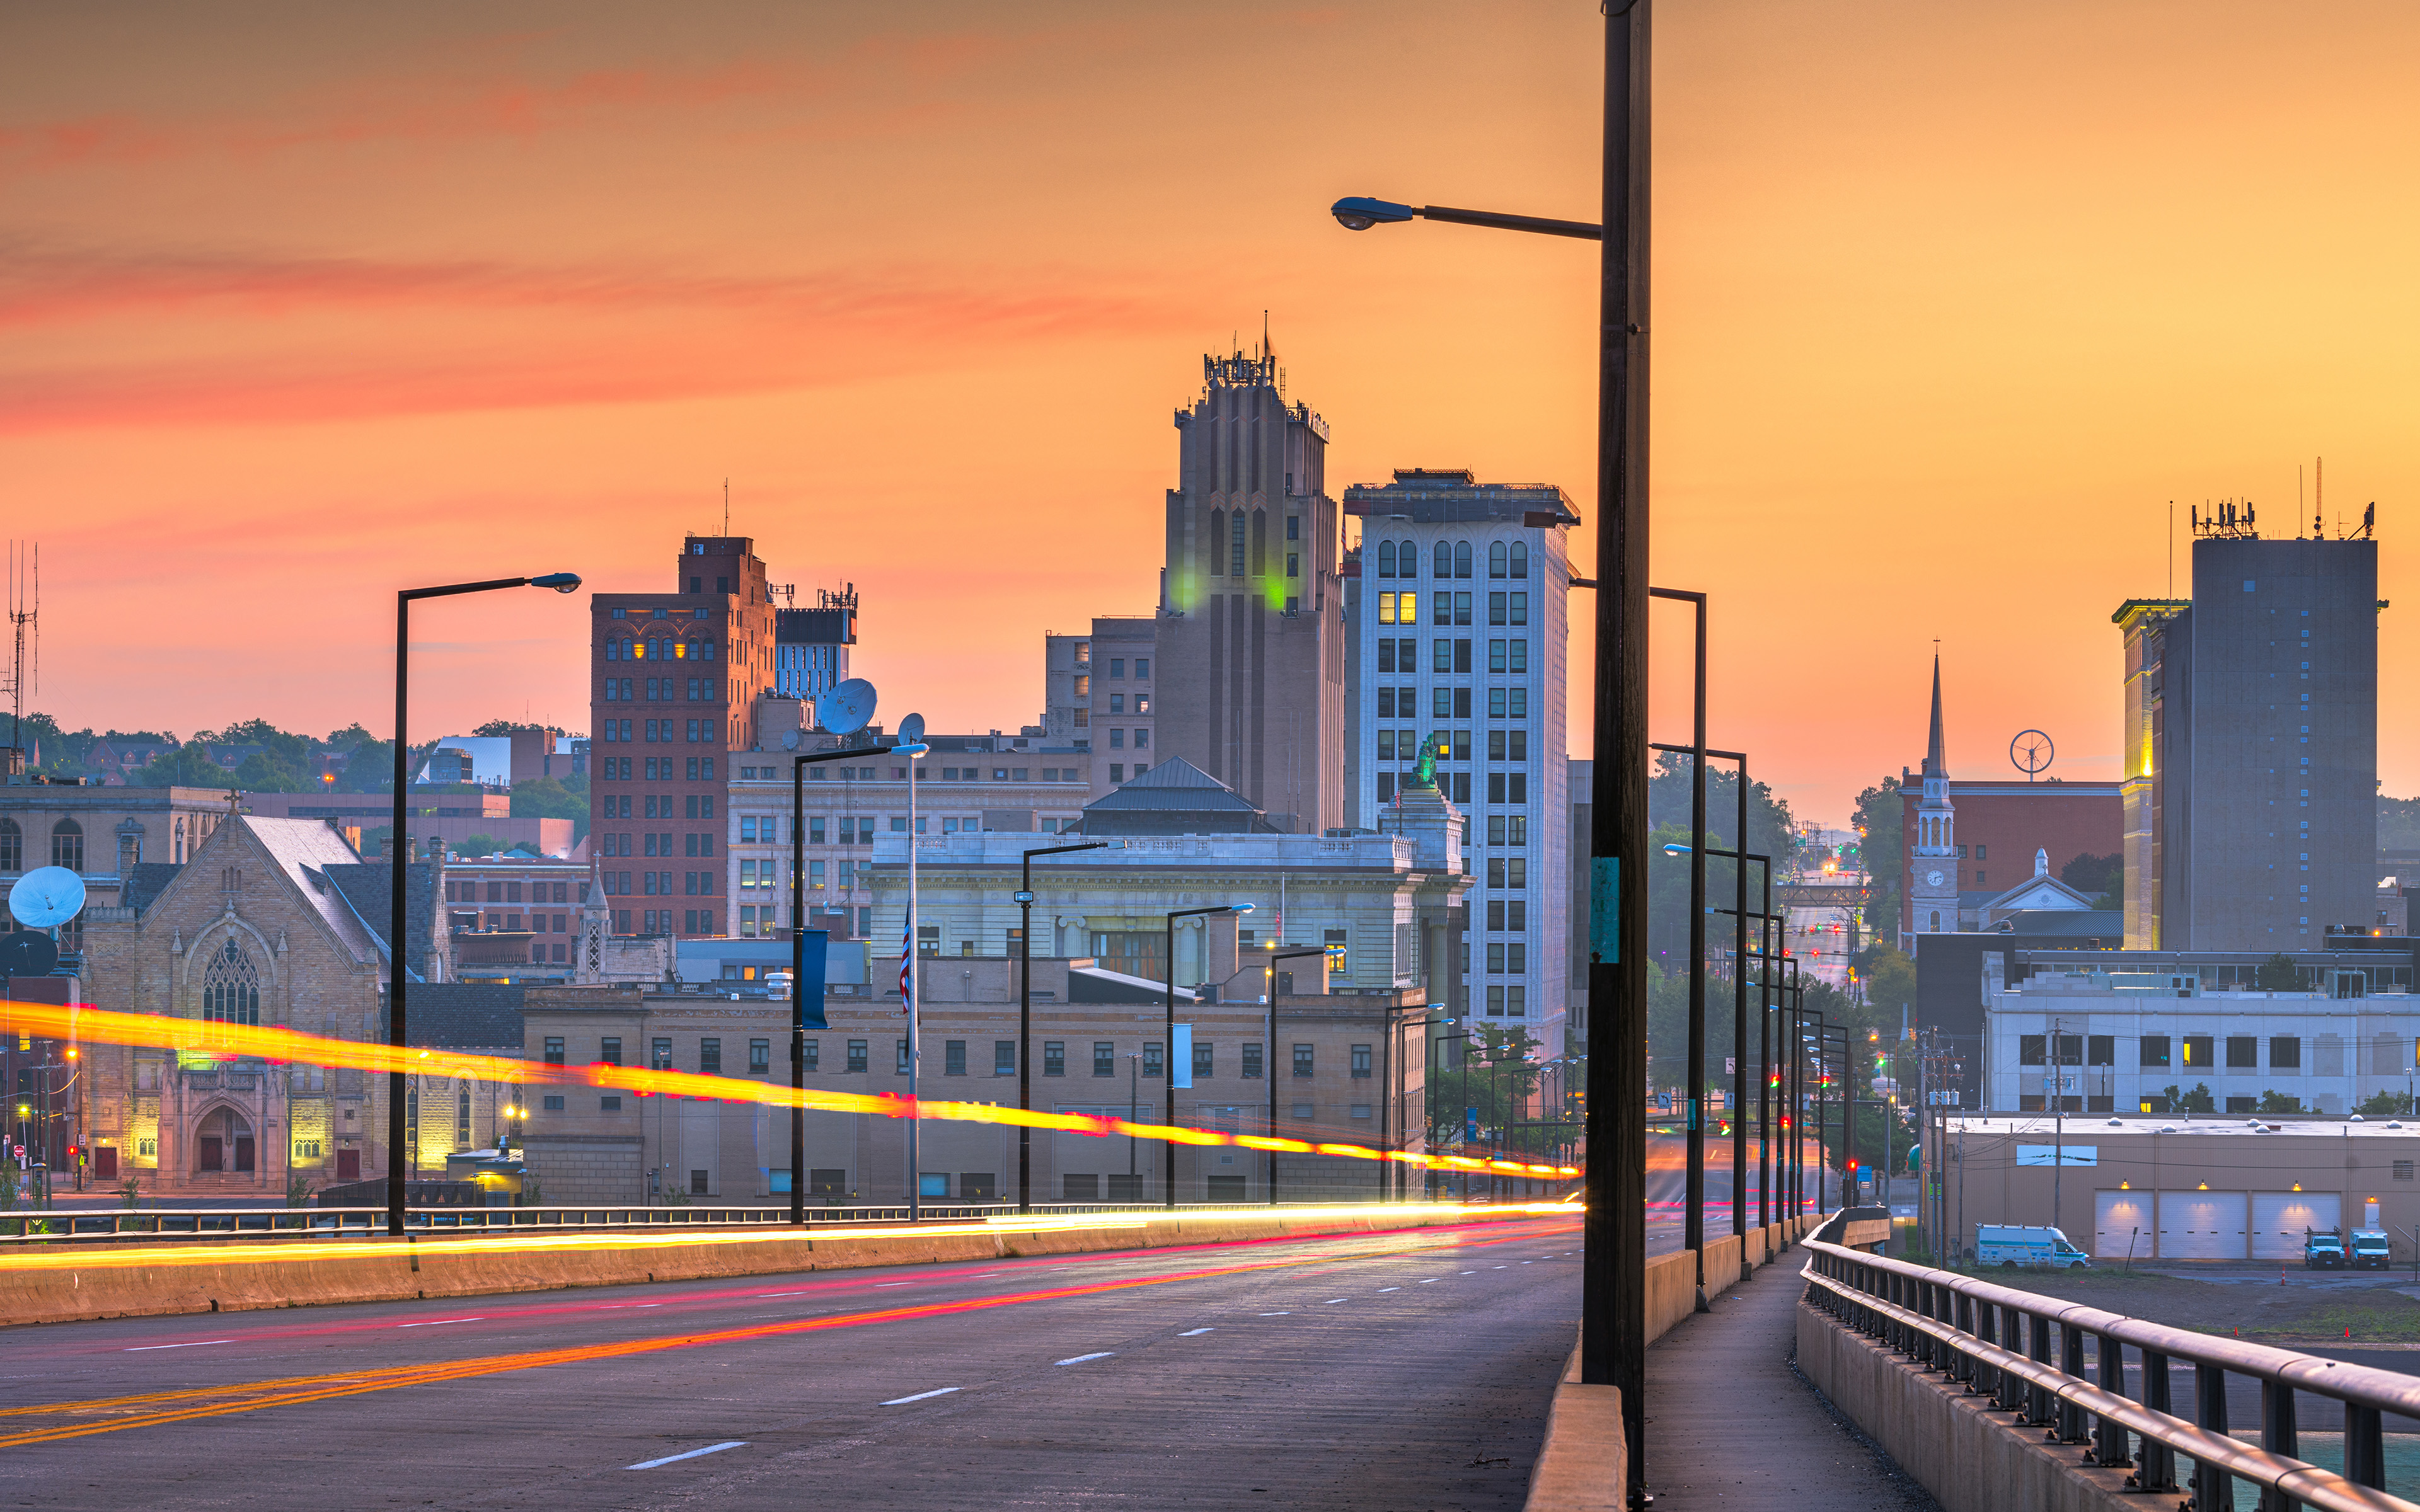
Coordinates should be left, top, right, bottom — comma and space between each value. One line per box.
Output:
588, 535, 775, 934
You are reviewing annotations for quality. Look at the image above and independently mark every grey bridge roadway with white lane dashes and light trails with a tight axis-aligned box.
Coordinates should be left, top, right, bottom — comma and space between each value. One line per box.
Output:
0, 1219, 1581, 1512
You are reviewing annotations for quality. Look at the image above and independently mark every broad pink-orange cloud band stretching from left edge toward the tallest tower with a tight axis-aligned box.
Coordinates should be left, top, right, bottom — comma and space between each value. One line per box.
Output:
0, 247, 1196, 433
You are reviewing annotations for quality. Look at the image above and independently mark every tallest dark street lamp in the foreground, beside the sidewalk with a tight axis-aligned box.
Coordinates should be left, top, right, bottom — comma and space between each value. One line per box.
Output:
1331, 0, 1653, 1461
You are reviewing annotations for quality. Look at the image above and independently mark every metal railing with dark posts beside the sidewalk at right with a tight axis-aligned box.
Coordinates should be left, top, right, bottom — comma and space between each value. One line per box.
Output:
1806, 1239, 2420, 1512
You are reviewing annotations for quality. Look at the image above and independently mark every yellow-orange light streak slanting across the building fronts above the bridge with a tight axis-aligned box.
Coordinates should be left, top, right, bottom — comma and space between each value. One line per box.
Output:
5, 1002, 1581, 1178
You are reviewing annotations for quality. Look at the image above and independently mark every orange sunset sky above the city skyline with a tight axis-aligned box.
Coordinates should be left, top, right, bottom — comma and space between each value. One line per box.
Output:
0, 0, 2420, 823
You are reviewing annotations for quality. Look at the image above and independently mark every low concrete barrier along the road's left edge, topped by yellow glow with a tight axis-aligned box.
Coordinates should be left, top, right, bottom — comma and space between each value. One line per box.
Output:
0, 1194, 1548, 1323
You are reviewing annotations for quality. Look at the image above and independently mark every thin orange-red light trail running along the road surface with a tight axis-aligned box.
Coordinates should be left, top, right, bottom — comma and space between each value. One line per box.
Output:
0, 1210, 1587, 1449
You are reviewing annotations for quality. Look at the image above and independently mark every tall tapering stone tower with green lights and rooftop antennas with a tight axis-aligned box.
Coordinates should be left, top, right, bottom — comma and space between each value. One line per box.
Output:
1157, 351, 1345, 832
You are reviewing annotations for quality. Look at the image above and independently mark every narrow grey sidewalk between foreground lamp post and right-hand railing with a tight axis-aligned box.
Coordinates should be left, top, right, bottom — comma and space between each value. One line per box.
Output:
1645, 1248, 1939, 1512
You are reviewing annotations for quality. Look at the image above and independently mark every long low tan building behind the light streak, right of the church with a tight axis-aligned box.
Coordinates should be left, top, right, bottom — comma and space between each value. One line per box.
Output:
522, 958, 1426, 1205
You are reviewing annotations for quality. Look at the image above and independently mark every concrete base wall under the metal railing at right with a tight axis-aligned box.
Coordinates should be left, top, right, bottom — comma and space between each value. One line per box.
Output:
1798, 1302, 2139, 1512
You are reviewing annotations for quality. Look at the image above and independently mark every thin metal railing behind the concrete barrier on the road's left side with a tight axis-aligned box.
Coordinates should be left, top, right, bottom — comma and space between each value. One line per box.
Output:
0, 1202, 1306, 1248
